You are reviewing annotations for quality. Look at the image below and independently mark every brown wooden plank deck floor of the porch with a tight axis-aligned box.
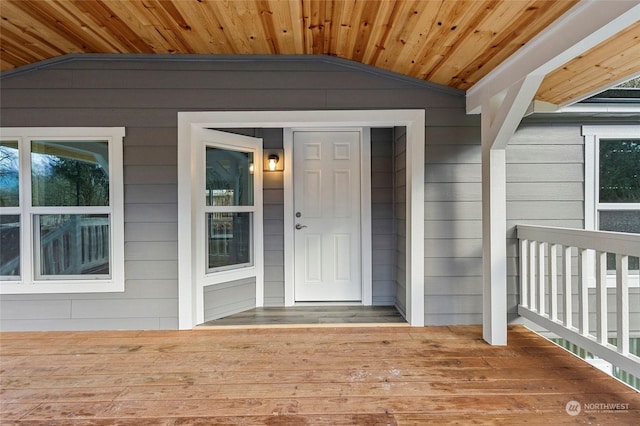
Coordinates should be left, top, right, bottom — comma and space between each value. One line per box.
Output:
0, 326, 640, 425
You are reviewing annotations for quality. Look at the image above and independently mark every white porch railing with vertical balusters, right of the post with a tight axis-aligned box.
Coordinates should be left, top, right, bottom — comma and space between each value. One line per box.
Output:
517, 225, 640, 377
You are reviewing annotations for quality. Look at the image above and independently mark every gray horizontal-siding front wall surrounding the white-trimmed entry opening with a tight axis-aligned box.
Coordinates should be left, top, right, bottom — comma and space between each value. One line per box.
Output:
0, 55, 481, 330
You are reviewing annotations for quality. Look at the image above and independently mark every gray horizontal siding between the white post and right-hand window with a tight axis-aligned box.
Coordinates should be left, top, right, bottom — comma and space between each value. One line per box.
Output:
507, 125, 584, 318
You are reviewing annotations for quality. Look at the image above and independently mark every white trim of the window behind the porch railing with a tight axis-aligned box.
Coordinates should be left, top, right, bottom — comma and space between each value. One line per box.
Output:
582, 125, 640, 288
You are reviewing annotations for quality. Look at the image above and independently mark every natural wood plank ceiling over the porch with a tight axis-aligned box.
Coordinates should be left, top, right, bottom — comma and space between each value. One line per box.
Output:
0, 0, 640, 104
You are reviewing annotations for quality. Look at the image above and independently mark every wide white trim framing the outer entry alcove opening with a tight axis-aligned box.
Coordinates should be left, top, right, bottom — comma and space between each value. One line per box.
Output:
178, 110, 425, 329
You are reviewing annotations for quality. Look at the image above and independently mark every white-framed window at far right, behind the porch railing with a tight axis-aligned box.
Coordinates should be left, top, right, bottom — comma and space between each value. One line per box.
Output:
583, 126, 640, 281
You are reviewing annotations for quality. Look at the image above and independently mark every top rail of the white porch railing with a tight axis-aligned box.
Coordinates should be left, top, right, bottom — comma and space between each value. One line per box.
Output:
516, 225, 640, 257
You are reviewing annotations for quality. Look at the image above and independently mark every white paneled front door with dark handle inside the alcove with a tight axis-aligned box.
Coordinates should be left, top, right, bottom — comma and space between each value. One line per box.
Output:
293, 130, 362, 302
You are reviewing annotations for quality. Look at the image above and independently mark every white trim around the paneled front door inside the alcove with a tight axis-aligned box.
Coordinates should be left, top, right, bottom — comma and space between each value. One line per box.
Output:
283, 127, 373, 306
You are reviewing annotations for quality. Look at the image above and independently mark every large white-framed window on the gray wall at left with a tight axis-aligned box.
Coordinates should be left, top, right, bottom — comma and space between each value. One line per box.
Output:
0, 128, 124, 294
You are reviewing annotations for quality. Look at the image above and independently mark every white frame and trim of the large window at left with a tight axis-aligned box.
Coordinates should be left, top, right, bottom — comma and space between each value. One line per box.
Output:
0, 127, 125, 294
